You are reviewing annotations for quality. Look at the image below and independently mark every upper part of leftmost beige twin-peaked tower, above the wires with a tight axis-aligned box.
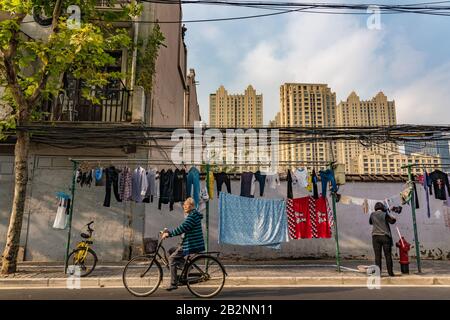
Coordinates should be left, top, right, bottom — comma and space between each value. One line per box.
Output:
209, 85, 263, 128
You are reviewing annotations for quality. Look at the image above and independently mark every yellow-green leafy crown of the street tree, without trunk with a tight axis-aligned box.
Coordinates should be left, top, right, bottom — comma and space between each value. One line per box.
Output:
0, 0, 134, 133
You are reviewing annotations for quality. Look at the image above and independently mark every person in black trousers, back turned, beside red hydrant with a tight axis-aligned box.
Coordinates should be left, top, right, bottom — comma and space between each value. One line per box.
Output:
369, 202, 396, 277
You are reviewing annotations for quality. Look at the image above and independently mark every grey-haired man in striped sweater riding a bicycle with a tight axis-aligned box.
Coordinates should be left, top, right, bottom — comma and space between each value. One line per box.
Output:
161, 198, 205, 291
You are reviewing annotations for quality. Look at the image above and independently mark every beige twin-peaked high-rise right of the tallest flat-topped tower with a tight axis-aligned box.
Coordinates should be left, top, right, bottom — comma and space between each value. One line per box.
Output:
336, 92, 398, 173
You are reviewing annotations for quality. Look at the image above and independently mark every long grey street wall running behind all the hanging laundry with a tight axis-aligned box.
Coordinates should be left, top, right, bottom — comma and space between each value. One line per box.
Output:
0, 157, 450, 261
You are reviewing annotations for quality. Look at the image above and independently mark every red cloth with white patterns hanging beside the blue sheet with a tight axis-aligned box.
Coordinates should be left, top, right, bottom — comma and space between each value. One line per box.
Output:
286, 196, 331, 239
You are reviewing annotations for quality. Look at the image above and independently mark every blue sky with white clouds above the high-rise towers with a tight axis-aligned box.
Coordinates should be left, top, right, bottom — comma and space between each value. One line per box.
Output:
183, 0, 450, 124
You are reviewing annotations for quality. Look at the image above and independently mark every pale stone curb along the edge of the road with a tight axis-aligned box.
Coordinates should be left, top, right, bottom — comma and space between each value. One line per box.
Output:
0, 276, 450, 290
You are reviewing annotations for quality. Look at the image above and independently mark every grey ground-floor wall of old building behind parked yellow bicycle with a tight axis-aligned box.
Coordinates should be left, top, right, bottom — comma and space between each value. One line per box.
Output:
0, 146, 146, 261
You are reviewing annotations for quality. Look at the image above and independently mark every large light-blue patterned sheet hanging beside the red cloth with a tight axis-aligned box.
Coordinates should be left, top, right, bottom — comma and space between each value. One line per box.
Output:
219, 192, 288, 249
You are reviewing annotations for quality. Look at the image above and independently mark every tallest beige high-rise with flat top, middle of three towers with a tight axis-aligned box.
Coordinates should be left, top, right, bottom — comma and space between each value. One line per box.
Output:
276, 83, 336, 168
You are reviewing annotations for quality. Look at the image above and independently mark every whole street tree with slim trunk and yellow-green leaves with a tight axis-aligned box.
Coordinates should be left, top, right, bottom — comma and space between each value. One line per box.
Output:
0, 0, 135, 274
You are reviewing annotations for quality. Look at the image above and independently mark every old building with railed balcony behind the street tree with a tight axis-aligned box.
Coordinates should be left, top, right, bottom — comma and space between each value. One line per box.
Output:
0, 2, 200, 261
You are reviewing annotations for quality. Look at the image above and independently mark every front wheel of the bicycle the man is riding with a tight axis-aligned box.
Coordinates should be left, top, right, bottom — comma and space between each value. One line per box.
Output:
122, 256, 162, 297
